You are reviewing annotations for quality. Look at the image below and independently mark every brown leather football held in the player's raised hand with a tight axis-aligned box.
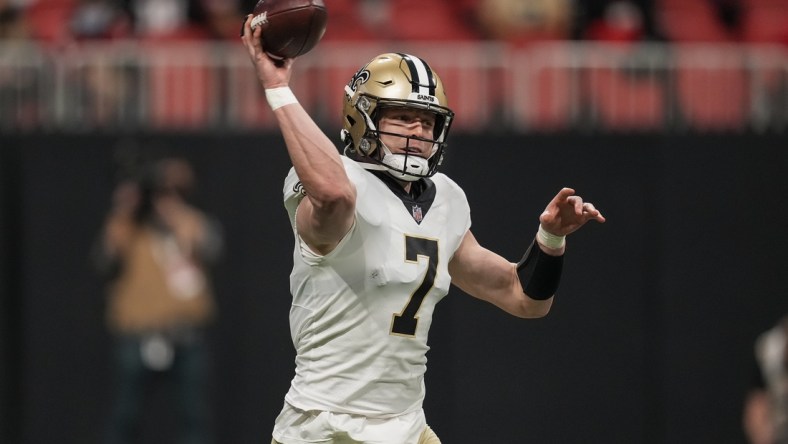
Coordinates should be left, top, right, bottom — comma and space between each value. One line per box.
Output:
252, 0, 328, 59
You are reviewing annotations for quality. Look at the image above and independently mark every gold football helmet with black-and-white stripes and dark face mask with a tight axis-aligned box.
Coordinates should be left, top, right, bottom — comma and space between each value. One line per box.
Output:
342, 53, 454, 181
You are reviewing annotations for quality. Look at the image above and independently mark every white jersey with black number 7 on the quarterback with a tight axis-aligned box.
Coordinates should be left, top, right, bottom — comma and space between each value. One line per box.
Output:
284, 157, 471, 417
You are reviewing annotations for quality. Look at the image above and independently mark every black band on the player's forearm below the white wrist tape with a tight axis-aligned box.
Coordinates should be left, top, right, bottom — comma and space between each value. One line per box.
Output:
517, 240, 564, 301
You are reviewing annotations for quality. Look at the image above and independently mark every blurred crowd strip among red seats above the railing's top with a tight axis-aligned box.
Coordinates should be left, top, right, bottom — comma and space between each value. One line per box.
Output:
0, 0, 788, 45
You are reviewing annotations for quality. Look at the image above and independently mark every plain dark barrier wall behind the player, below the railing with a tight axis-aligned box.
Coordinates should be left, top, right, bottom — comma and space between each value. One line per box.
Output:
0, 134, 788, 444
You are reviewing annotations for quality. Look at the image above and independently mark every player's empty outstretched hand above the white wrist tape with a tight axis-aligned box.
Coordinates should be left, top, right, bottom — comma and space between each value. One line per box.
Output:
539, 188, 605, 236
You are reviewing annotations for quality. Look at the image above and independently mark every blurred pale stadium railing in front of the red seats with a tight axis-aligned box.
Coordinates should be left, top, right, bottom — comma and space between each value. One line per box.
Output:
0, 41, 788, 133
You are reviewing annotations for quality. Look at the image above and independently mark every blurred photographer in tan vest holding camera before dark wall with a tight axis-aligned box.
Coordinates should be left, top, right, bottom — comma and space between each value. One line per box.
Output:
96, 159, 222, 444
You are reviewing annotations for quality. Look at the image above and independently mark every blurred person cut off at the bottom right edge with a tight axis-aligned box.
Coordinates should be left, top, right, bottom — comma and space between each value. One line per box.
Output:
743, 316, 788, 444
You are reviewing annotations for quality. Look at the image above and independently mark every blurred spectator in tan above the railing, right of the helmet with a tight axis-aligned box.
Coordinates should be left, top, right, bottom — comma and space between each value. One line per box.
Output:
477, 0, 574, 45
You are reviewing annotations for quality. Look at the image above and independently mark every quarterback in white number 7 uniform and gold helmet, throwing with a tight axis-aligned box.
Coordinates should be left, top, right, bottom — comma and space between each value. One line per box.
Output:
242, 17, 605, 444
